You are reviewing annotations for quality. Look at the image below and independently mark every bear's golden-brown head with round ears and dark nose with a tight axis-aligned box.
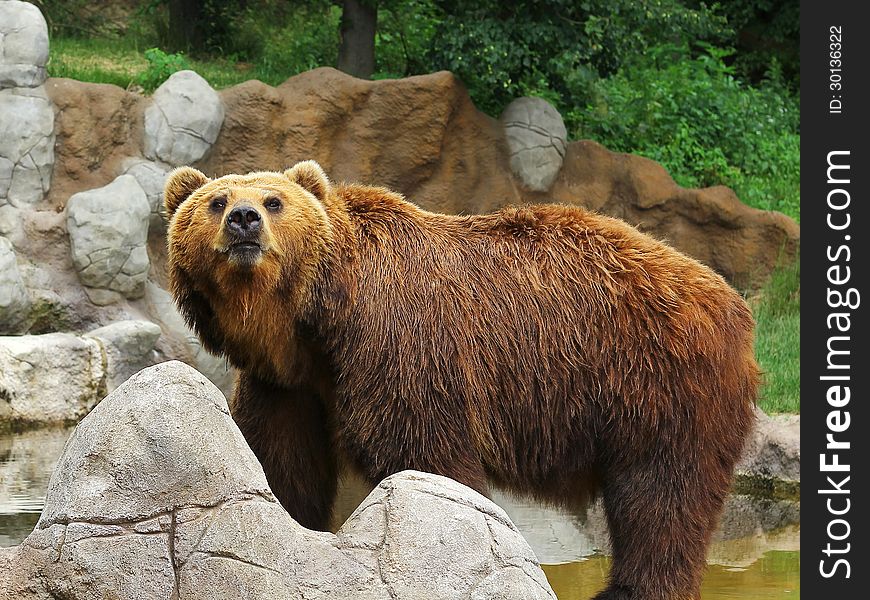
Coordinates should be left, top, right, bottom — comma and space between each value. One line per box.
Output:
164, 161, 331, 294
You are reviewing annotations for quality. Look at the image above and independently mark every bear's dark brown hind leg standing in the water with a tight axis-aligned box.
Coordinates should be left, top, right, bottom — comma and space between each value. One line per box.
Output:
595, 448, 731, 600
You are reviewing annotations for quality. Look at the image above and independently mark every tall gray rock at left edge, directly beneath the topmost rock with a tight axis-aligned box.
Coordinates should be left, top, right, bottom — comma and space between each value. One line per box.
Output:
0, 84, 54, 207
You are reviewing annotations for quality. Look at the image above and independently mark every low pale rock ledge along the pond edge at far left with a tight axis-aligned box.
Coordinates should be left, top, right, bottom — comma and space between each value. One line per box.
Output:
0, 321, 160, 423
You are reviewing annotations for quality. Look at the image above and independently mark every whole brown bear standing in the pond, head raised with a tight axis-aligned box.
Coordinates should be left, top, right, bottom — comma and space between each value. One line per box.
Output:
165, 161, 759, 600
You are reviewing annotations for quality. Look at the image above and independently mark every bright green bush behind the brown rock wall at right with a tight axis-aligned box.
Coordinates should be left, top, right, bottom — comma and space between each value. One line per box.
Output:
565, 46, 800, 219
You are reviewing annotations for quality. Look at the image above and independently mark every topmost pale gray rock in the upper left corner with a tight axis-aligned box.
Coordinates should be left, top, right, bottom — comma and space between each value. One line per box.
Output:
0, 0, 48, 88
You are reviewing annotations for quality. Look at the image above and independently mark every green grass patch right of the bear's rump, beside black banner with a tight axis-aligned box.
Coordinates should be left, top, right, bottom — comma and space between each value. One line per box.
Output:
750, 257, 801, 413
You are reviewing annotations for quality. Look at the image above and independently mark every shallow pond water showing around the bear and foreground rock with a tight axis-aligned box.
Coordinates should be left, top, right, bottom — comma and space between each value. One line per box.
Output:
0, 427, 800, 600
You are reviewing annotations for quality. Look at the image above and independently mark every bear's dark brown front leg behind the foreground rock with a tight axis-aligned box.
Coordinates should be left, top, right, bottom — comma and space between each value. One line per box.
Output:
231, 372, 338, 531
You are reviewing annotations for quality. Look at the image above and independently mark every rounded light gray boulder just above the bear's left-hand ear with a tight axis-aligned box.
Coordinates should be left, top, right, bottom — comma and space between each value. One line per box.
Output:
144, 71, 224, 166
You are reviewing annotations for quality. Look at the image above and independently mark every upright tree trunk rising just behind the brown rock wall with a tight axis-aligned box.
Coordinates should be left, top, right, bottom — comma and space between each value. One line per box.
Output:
338, 0, 378, 79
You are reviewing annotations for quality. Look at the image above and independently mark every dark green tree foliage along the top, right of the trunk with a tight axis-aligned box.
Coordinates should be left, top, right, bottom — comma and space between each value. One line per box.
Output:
427, 0, 728, 113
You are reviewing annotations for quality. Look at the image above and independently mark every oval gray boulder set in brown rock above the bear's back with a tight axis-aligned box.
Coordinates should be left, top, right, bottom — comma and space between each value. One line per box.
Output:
501, 98, 568, 192
